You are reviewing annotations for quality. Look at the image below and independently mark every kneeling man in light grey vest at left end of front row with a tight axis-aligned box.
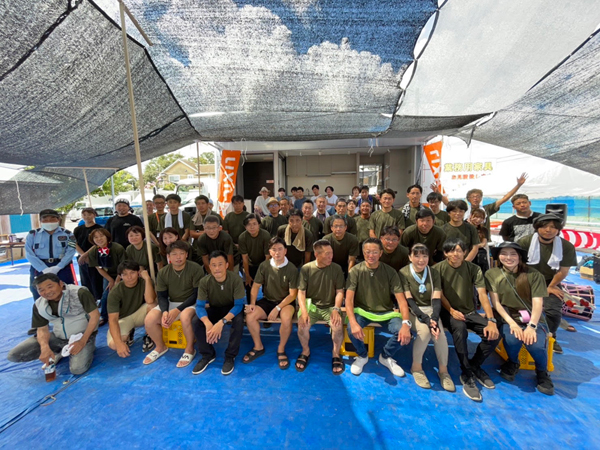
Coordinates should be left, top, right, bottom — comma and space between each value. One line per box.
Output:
7, 273, 100, 375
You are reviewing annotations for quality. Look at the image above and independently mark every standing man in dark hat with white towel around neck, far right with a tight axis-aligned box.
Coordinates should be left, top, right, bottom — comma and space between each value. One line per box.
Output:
517, 214, 577, 354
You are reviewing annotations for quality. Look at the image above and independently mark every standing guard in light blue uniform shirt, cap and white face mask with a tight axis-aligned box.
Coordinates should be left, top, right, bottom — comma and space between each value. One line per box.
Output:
25, 209, 77, 335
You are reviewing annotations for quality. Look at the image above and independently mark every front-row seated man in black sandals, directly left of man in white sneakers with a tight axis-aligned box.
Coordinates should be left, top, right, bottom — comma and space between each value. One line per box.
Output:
296, 239, 344, 375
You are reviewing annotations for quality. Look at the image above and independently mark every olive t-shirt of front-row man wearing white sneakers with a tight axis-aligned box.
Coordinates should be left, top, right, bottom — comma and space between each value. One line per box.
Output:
346, 261, 404, 313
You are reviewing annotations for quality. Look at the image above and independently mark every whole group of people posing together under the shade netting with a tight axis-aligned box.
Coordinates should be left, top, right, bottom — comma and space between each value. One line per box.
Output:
8, 175, 576, 401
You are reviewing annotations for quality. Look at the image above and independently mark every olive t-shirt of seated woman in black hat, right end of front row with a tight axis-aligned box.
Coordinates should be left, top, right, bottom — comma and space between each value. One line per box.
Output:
485, 267, 548, 323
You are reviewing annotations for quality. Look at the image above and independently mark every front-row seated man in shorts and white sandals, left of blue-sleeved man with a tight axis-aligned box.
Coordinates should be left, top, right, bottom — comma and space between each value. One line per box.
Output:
144, 241, 204, 367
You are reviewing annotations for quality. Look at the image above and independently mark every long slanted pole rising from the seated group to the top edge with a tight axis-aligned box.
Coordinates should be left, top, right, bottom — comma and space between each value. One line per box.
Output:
119, 0, 156, 280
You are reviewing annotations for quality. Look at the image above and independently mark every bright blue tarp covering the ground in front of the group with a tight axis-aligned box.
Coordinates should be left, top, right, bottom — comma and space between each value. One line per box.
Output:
0, 261, 600, 450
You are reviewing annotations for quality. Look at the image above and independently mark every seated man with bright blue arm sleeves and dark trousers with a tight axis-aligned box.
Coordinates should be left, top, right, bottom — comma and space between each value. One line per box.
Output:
192, 250, 246, 375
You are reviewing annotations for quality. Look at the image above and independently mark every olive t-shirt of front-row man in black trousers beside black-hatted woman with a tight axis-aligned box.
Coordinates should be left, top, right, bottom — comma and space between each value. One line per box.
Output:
433, 260, 485, 314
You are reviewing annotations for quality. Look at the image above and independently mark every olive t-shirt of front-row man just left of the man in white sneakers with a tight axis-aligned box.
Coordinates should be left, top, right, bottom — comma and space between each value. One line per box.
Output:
298, 261, 344, 309
